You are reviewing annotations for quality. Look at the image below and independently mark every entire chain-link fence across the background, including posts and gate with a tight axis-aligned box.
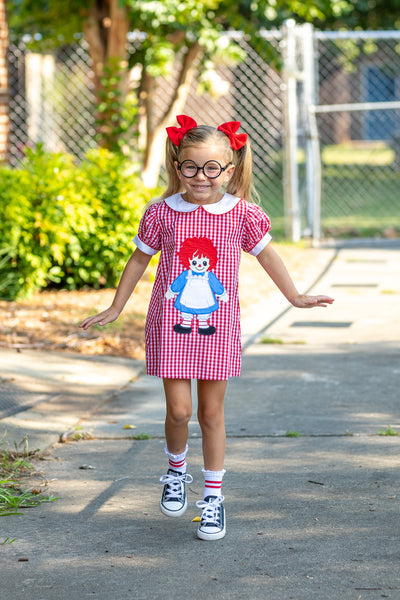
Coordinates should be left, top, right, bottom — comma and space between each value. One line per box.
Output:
5, 25, 400, 239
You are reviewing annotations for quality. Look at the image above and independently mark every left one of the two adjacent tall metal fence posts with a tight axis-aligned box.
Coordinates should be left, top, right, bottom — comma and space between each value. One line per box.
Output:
282, 19, 301, 242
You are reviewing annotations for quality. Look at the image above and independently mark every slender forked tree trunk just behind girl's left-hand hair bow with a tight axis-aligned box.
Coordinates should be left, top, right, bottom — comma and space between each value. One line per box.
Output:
142, 42, 202, 188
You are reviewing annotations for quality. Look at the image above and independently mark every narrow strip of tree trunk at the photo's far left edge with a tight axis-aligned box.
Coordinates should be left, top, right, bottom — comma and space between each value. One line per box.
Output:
0, 0, 10, 162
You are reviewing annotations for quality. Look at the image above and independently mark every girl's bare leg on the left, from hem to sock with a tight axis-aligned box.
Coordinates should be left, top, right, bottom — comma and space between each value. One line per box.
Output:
163, 379, 192, 454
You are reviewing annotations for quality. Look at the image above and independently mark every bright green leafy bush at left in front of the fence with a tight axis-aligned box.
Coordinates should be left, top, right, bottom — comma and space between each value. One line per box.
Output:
0, 146, 152, 299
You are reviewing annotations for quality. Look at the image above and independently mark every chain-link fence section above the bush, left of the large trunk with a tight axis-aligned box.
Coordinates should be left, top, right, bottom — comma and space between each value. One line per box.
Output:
8, 42, 96, 166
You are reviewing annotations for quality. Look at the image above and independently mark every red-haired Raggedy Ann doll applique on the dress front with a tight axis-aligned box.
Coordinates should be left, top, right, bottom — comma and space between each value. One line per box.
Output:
165, 237, 229, 335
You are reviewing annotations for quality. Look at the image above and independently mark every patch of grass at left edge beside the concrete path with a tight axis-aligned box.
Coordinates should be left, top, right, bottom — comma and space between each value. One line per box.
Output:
0, 442, 56, 516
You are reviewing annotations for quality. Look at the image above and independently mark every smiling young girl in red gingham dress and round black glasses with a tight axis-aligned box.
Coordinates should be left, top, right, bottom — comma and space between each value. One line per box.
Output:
80, 115, 333, 540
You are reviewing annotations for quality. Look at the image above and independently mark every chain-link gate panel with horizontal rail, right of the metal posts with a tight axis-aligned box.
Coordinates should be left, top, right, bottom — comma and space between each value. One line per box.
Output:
315, 31, 400, 237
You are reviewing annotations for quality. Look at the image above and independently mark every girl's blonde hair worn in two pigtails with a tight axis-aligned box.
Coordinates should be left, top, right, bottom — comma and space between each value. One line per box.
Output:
162, 125, 258, 201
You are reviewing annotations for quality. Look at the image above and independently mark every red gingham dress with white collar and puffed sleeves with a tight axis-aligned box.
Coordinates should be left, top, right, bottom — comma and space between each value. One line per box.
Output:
134, 194, 271, 380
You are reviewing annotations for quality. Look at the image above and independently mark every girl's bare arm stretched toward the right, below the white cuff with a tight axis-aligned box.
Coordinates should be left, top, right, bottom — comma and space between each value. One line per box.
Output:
257, 244, 334, 308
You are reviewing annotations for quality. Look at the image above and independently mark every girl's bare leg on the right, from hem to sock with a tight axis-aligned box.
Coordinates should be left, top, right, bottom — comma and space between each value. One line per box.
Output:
197, 380, 227, 471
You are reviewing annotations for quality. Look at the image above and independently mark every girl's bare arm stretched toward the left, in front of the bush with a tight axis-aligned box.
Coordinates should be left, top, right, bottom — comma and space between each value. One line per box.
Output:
79, 248, 151, 329
